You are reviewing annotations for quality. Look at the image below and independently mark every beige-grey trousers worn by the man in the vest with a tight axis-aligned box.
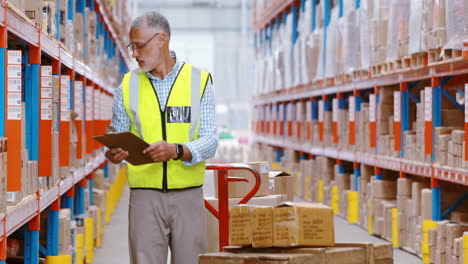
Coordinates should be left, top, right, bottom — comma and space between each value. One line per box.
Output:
128, 187, 207, 264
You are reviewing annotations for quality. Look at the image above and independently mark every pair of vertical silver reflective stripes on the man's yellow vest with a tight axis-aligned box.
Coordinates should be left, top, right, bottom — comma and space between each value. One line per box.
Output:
130, 67, 201, 141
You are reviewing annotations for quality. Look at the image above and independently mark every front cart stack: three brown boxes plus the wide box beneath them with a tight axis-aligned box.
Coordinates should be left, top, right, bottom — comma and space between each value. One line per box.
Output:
199, 200, 393, 264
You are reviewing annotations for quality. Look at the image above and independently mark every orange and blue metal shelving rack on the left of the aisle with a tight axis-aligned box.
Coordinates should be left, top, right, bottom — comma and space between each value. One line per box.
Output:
0, 0, 131, 264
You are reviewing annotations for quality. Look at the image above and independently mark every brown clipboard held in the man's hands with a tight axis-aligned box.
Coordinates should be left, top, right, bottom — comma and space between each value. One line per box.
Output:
93, 132, 154, 166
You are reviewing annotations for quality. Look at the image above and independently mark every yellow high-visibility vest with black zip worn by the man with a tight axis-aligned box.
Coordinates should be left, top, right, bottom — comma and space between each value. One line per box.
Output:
122, 64, 211, 191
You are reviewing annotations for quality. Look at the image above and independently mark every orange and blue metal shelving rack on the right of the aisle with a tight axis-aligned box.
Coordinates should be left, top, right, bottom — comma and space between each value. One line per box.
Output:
252, 0, 468, 229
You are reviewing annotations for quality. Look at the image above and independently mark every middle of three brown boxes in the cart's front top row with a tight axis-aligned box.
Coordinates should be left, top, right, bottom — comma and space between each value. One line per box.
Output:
251, 206, 273, 248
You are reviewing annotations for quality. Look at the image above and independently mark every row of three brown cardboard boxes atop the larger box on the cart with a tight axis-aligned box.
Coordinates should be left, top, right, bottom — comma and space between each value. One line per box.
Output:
229, 203, 335, 248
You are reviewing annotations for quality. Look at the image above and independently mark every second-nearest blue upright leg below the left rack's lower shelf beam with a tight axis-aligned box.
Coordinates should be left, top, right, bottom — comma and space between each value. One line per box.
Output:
47, 199, 60, 256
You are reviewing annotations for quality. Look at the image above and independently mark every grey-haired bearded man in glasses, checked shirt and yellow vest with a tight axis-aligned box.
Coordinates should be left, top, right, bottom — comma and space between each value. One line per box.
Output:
106, 12, 218, 264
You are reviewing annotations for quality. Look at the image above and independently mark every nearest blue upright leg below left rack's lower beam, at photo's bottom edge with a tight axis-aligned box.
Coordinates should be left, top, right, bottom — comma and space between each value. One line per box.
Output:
24, 212, 41, 264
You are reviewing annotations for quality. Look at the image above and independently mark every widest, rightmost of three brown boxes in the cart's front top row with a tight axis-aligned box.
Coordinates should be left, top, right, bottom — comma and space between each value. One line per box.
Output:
273, 203, 335, 247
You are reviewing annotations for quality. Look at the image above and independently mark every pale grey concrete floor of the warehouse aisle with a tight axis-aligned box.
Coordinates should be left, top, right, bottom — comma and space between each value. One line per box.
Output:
94, 172, 422, 264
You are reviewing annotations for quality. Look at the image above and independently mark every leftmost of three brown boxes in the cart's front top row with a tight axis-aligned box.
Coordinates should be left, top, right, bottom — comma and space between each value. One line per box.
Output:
229, 205, 252, 246
